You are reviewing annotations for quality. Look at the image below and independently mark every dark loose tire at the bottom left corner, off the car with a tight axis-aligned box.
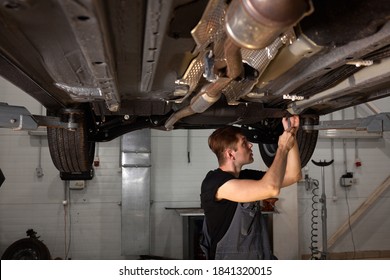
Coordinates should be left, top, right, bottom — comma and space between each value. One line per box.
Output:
1, 237, 51, 260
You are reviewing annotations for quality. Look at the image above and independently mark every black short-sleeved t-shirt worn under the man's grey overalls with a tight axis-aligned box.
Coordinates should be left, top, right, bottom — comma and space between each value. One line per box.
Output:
200, 168, 265, 258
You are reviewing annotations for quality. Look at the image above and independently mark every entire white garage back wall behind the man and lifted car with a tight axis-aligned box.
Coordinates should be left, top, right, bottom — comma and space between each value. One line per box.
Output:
0, 76, 390, 259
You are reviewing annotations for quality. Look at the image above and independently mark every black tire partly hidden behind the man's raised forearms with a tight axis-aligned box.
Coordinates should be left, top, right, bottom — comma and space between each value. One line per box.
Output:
259, 117, 318, 168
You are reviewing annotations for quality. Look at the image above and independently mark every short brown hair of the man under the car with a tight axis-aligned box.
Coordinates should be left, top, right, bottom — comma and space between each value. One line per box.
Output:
209, 126, 243, 164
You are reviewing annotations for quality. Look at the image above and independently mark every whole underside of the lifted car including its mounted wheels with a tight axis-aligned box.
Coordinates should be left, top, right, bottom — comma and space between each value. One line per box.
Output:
0, 0, 390, 179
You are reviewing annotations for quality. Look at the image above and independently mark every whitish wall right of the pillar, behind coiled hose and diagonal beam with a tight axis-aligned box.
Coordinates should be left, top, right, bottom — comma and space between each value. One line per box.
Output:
298, 106, 390, 257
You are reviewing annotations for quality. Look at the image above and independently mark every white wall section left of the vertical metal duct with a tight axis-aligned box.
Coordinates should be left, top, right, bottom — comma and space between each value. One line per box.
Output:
0, 77, 122, 259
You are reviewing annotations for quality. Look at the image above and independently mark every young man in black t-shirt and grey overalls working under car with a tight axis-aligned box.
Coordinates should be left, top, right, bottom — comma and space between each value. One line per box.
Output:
201, 116, 302, 259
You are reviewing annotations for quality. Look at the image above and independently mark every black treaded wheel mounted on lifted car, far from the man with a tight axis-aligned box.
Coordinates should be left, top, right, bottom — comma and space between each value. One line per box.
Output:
47, 110, 95, 180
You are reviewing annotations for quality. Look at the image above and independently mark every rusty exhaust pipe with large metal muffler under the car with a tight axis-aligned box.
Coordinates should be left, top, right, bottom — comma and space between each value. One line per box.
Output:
165, 0, 313, 130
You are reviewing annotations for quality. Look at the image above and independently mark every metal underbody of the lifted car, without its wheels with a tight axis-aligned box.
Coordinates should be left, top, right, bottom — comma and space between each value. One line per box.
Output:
0, 0, 390, 122
